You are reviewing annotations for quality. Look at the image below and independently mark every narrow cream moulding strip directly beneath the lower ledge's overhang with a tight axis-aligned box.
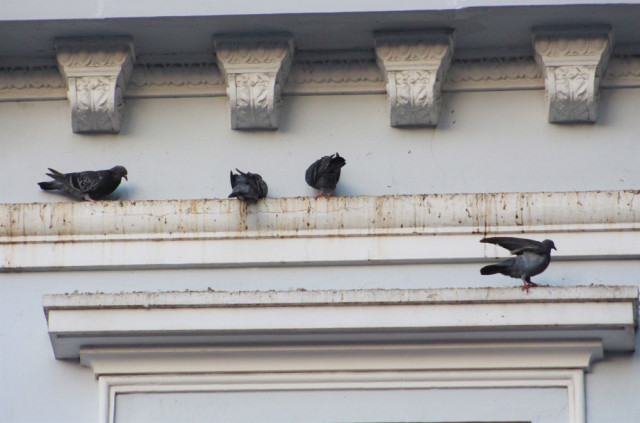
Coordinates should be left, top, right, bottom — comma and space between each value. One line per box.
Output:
79, 340, 604, 376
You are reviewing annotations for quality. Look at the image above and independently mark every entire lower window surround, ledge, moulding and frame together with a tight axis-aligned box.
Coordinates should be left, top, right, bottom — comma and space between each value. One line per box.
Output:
43, 286, 638, 423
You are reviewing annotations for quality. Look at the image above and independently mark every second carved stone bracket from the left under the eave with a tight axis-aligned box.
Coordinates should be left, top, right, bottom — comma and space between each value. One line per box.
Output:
214, 34, 293, 129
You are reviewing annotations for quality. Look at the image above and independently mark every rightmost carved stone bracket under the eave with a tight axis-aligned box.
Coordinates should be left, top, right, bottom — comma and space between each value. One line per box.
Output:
533, 26, 612, 123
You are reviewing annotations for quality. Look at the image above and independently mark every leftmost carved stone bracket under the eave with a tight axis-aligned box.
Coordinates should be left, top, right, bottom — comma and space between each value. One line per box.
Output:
55, 37, 135, 133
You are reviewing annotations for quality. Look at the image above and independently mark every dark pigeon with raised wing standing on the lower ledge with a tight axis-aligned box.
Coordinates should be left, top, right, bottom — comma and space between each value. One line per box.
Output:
480, 237, 556, 291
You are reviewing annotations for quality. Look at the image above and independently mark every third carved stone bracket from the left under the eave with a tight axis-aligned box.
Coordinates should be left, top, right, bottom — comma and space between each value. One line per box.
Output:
375, 31, 453, 127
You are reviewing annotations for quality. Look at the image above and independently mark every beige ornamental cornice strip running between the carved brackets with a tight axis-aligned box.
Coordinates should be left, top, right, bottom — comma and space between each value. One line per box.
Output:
0, 51, 640, 101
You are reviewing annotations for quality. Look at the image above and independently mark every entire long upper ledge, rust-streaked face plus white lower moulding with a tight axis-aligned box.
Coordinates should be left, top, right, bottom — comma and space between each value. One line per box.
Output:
0, 191, 640, 272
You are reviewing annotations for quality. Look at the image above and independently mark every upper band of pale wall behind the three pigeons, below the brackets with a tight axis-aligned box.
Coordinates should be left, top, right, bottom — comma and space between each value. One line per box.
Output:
0, 89, 640, 202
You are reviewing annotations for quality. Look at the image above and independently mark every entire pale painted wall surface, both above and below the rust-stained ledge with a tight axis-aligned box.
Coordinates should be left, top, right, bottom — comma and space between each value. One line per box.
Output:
0, 89, 640, 423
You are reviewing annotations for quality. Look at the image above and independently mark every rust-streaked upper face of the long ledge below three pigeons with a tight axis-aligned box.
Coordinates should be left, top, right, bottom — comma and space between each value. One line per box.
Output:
0, 191, 640, 242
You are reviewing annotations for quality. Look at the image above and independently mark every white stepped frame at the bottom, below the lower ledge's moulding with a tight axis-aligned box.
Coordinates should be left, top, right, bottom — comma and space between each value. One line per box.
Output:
98, 369, 586, 423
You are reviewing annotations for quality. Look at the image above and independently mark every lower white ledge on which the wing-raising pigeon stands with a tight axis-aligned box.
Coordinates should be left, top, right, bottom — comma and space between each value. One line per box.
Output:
43, 286, 638, 366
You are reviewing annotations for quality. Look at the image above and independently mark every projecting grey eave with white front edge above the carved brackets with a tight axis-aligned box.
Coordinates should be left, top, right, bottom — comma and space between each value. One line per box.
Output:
0, 0, 640, 57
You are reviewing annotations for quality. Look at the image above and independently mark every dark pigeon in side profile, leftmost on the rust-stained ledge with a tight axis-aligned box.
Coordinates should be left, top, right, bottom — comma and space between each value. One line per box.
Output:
38, 166, 129, 201
